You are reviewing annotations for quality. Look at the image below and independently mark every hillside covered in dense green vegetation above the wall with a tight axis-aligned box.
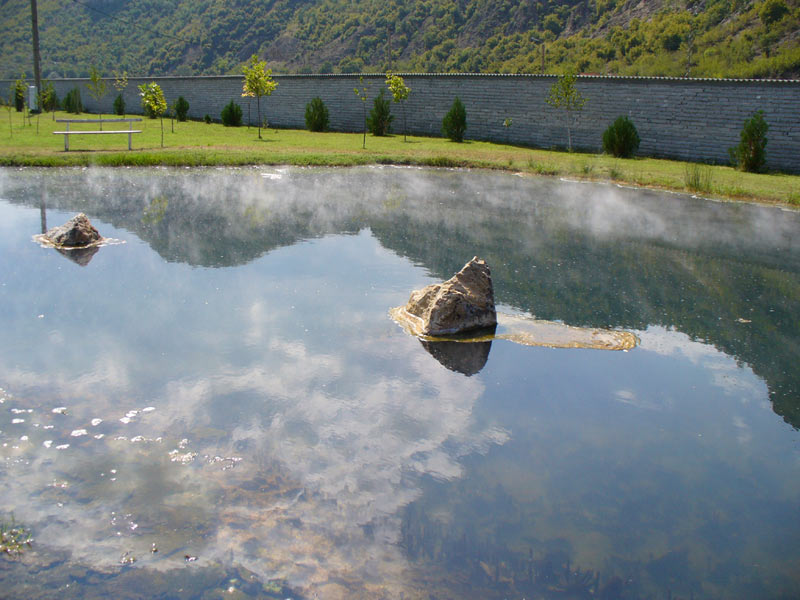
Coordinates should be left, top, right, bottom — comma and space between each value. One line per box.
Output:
0, 0, 800, 78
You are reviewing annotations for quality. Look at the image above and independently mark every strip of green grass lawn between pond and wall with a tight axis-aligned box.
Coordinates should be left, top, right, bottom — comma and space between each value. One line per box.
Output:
0, 111, 800, 206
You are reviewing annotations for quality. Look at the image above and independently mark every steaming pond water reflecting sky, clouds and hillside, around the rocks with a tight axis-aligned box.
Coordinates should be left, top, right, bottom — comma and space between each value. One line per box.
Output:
0, 167, 800, 598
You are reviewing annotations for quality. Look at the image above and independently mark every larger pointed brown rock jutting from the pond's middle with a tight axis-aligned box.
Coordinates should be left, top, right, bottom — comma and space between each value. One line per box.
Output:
405, 256, 497, 336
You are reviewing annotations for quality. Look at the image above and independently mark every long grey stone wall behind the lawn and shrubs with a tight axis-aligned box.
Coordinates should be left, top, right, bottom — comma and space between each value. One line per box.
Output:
0, 74, 800, 172
